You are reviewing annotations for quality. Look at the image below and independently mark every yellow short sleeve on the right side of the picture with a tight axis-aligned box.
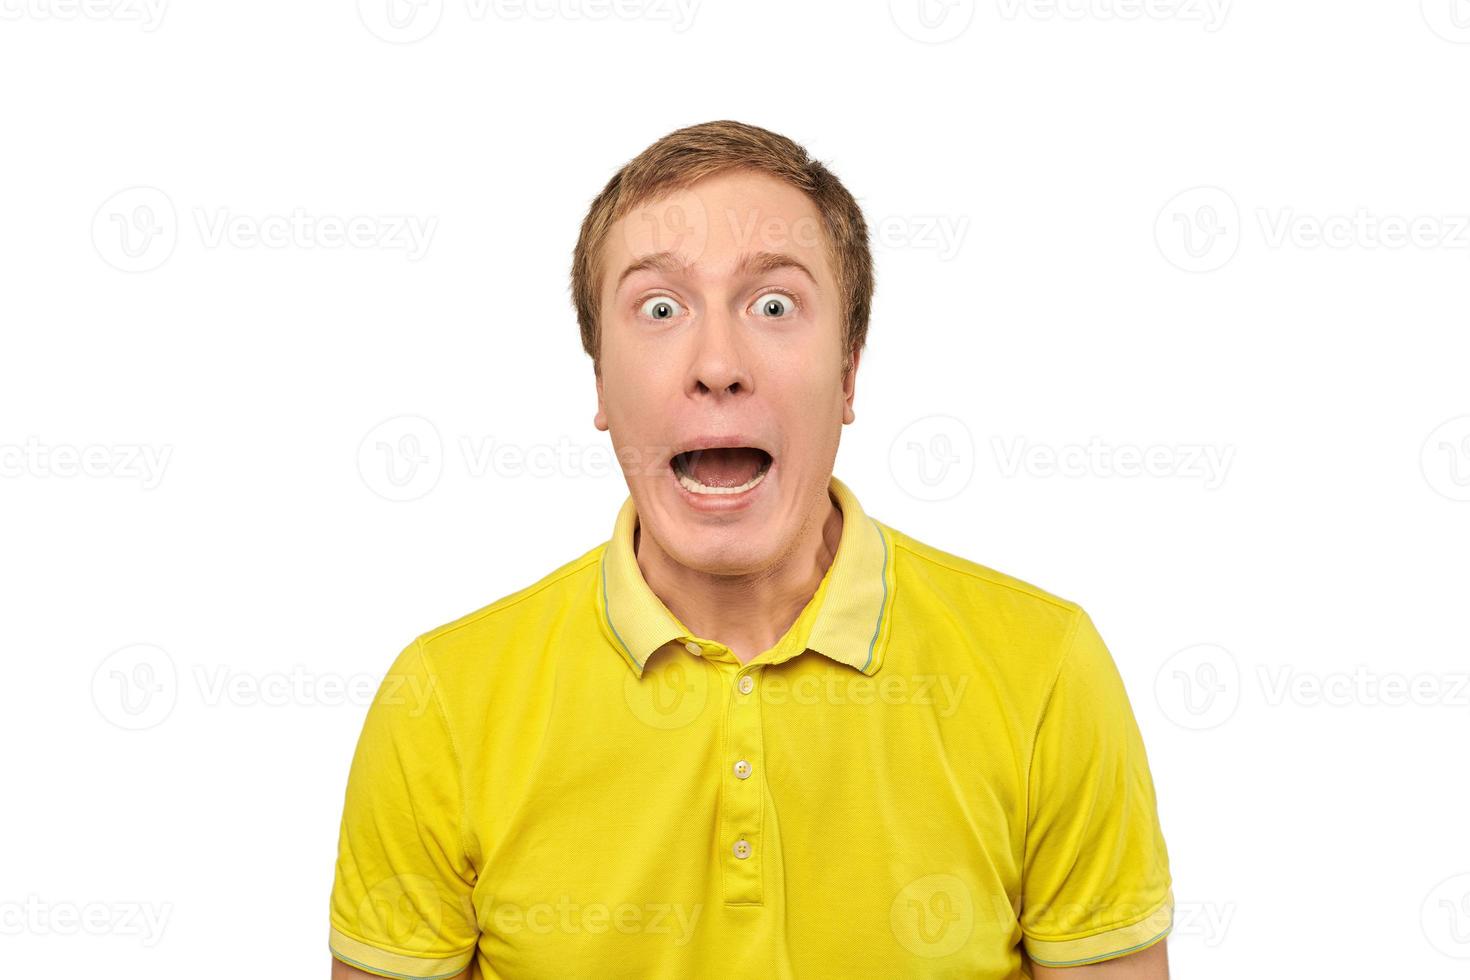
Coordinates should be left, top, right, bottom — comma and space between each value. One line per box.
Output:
1020, 610, 1173, 967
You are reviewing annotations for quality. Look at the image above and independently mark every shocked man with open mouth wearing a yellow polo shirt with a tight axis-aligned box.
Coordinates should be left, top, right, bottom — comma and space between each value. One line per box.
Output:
331, 122, 1173, 980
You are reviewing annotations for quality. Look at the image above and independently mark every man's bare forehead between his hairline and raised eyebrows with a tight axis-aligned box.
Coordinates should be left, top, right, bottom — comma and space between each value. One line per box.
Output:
603, 170, 833, 294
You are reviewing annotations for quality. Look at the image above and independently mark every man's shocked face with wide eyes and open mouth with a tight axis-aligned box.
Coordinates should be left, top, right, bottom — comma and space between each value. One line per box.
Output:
595, 170, 857, 574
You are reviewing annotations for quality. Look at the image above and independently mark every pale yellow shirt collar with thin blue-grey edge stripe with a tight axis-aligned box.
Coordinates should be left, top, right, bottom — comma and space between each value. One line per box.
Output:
598, 476, 894, 677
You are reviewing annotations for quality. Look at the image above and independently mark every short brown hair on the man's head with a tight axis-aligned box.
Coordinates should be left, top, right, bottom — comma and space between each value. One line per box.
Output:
572, 119, 873, 376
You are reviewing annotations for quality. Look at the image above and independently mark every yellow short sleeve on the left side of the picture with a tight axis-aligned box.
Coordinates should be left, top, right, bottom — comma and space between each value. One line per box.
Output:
331, 641, 479, 980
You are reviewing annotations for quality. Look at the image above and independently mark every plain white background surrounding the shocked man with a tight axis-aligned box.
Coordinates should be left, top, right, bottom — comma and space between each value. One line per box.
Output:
0, 0, 1470, 977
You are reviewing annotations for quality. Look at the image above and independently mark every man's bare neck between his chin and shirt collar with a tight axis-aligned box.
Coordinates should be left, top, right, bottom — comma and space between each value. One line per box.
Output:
634, 491, 842, 664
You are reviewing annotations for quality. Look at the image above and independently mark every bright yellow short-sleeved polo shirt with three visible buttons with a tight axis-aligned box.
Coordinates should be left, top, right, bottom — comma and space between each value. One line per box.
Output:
331, 478, 1173, 980
